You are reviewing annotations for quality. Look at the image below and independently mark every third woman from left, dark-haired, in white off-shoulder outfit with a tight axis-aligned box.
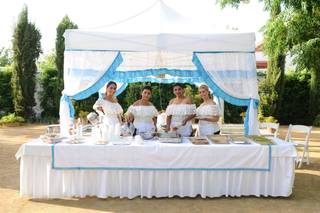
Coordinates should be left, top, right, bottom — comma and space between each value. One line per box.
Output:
166, 84, 196, 137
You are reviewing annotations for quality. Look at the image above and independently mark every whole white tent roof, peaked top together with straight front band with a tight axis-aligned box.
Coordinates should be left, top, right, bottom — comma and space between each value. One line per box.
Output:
65, 0, 255, 52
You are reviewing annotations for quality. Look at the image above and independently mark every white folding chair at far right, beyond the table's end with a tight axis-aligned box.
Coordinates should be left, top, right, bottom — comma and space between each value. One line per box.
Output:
285, 124, 312, 168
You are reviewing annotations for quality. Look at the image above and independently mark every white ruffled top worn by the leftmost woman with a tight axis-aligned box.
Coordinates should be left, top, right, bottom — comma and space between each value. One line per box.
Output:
93, 99, 123, 125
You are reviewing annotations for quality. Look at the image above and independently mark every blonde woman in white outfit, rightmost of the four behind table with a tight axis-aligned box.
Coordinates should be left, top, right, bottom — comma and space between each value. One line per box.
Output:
196, 85, 220, 136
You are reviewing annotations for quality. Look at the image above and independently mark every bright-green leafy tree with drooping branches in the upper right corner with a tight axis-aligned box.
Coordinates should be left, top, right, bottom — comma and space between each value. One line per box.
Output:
219, 0, 320, 124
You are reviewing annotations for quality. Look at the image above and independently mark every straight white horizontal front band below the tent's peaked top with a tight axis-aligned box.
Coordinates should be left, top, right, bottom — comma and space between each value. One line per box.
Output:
65, 30, 255, 52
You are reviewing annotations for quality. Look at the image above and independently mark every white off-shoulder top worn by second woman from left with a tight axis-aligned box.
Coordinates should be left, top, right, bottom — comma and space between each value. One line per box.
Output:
127, 105, 158, 133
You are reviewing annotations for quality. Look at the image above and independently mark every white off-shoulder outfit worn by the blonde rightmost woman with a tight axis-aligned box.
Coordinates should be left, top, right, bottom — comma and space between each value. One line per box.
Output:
196, 104, 220, 136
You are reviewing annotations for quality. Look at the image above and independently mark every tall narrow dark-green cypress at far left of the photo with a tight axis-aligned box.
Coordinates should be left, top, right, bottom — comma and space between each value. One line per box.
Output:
11, 6, 41, 117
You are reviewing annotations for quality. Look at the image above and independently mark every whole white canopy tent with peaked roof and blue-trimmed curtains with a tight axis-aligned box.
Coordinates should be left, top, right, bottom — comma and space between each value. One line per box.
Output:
60, 1, 259, 135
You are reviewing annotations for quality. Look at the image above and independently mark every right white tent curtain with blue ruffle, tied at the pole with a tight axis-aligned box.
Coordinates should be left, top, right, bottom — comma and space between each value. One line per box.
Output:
197, 52, 259, 135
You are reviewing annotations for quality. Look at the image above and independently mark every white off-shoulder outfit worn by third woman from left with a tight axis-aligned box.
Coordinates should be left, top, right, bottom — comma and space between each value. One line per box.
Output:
166, 104, 196, 137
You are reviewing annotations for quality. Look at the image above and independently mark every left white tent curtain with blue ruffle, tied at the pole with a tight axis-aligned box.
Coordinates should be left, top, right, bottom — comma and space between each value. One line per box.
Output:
59, 51, 118, 135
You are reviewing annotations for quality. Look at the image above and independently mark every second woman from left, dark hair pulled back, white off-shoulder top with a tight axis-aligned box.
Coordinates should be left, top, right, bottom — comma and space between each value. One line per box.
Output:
126, 86, 158, 134
